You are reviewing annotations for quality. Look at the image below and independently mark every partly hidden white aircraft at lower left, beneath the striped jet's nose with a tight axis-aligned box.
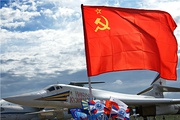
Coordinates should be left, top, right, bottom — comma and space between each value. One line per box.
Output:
0, 100, 71, 120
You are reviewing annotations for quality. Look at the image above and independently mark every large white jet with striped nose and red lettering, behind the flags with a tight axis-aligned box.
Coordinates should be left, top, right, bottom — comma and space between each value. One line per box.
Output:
4, 76, 180, 118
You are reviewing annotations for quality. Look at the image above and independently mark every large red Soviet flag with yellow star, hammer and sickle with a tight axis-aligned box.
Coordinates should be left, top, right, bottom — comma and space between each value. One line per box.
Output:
81, 5, 178, 80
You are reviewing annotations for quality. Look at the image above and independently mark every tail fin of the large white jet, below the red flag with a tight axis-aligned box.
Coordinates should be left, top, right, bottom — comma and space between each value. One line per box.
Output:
137, 74, 180, 98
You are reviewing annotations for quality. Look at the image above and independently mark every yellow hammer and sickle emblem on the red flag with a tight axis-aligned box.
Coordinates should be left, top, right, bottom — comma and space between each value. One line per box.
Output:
94, 15, 110, 32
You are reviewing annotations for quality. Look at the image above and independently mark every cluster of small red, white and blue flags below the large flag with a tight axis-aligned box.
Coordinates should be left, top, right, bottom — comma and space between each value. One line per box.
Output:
70, 98, 130, 120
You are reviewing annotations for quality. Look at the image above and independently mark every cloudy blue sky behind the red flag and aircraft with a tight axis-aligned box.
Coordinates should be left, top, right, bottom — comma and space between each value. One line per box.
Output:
0, 0, 180, 98
